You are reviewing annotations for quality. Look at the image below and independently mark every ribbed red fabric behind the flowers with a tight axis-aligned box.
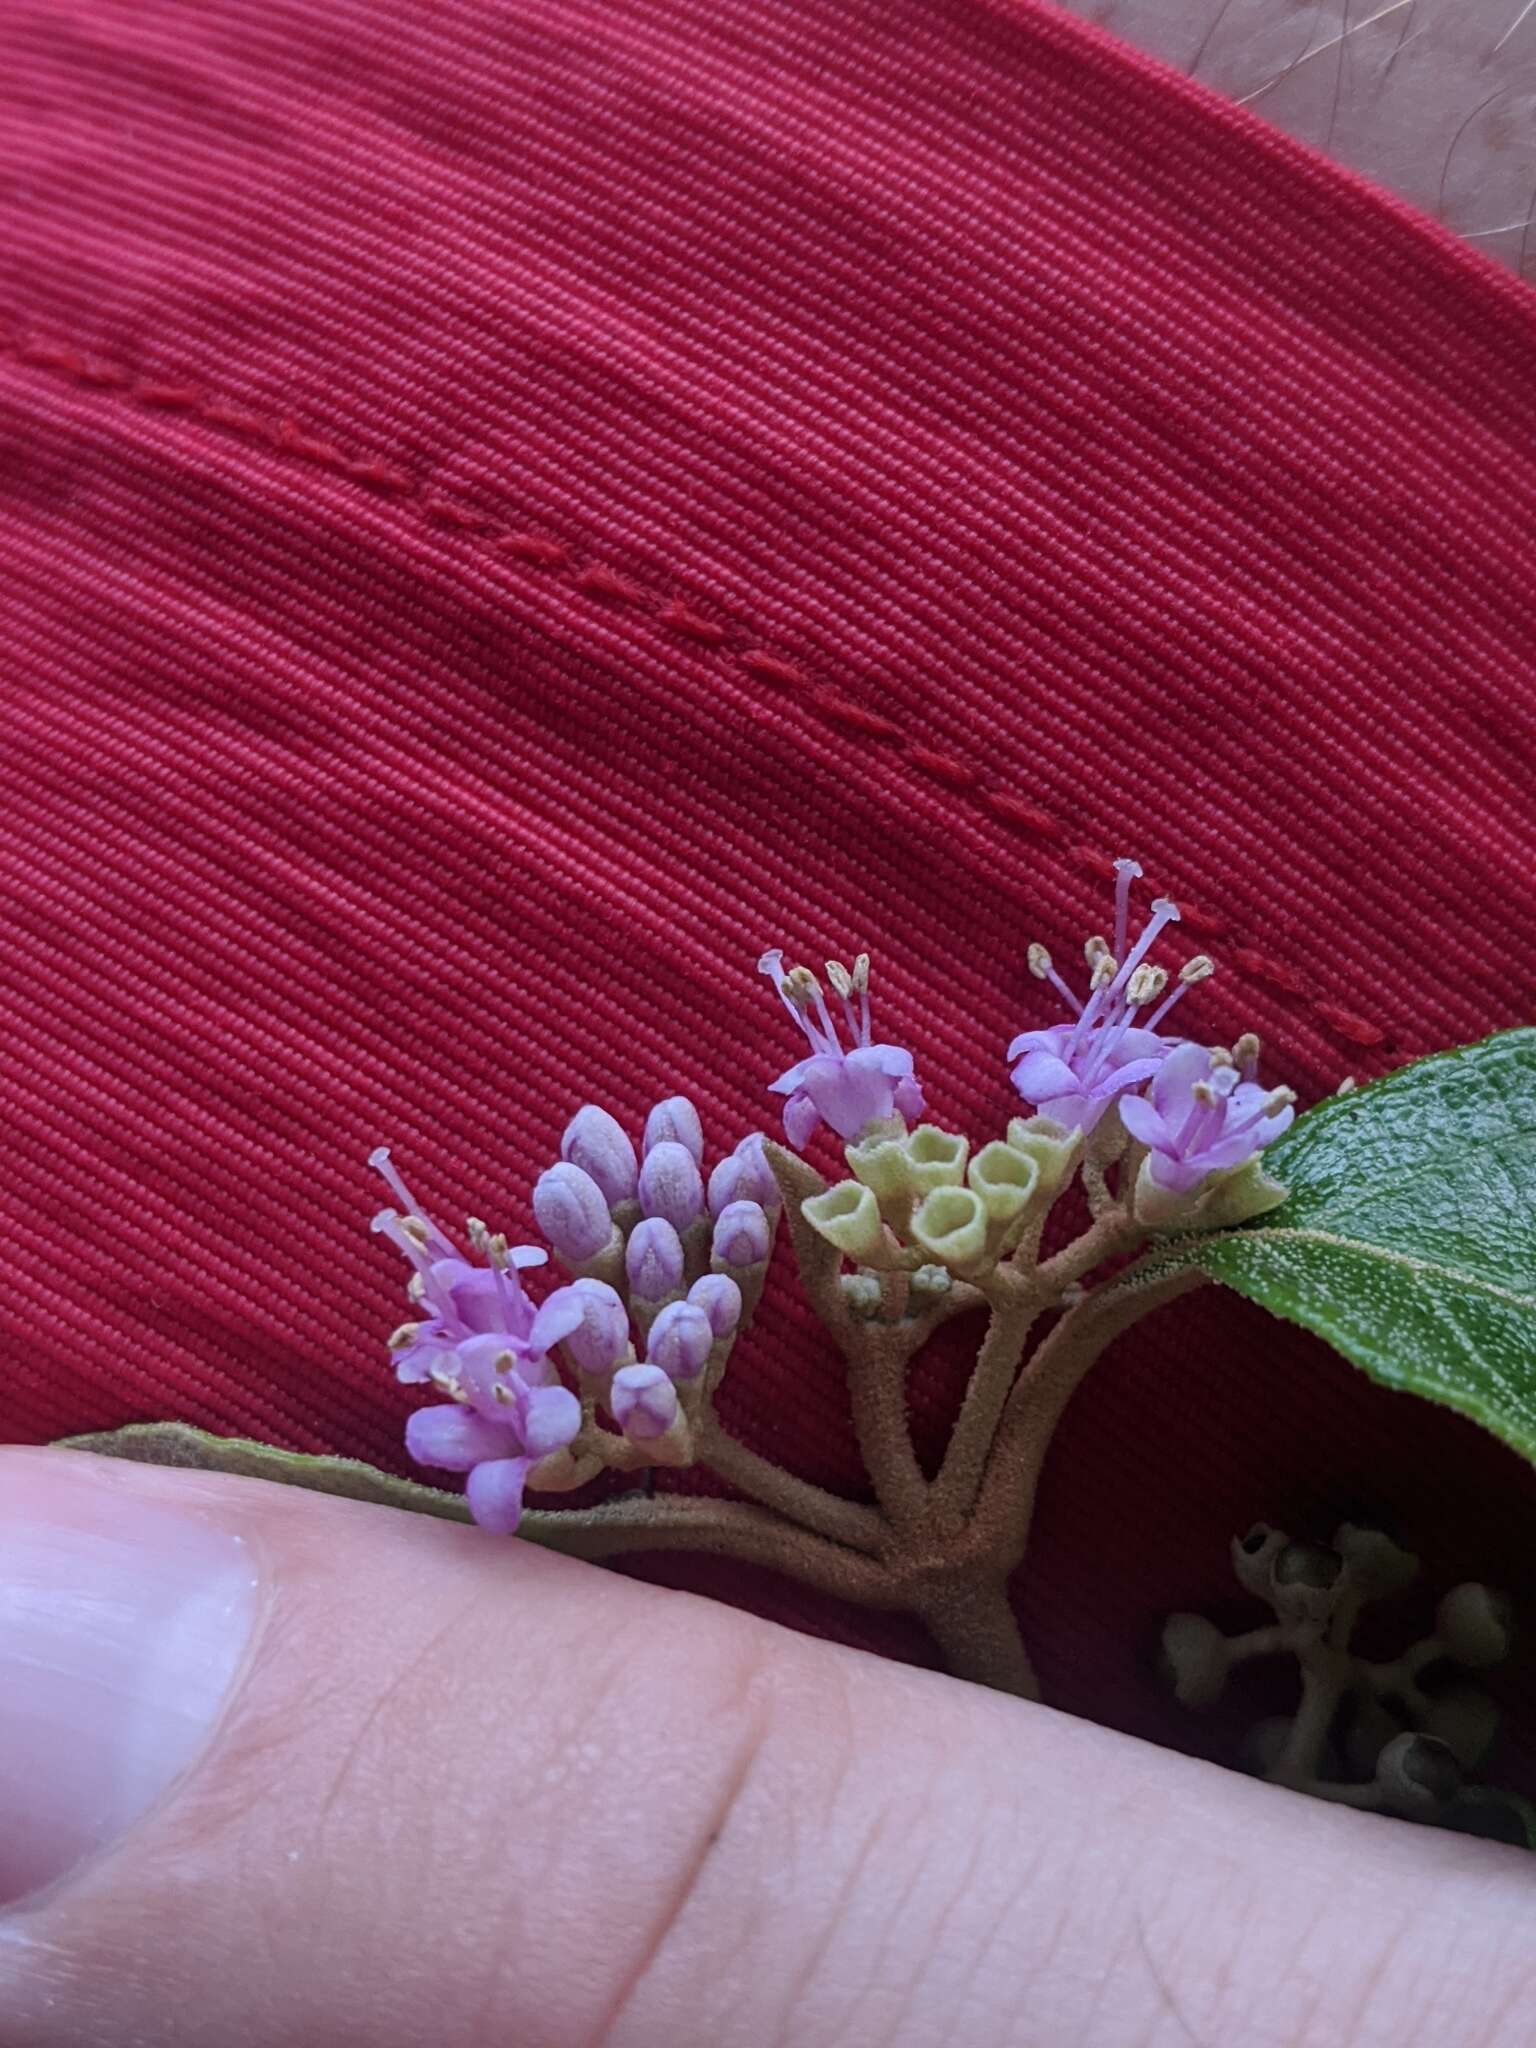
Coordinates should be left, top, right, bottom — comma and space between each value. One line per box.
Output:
0, 0, 1536, 1769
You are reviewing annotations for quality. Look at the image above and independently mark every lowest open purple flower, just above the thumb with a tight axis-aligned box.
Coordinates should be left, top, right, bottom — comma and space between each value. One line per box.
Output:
406, 1337, 582, 1536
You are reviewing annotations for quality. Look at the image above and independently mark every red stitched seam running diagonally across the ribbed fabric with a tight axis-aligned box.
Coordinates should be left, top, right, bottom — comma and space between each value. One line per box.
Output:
0, 328, 1393, 1051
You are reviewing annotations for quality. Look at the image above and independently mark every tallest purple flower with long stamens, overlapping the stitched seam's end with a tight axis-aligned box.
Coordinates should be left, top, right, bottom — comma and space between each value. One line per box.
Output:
1008, 860, 1210, 1130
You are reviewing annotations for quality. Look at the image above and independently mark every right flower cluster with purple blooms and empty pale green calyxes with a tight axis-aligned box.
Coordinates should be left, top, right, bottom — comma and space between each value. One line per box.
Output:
758, 860, 1294, 1277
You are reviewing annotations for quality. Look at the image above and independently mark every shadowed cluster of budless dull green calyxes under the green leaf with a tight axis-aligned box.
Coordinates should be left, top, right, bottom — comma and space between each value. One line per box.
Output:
1163, 1522, 1511, 1827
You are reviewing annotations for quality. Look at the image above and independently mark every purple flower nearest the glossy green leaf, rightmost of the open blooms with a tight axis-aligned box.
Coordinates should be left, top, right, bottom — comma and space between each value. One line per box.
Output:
1120, 1044, 1296, 1194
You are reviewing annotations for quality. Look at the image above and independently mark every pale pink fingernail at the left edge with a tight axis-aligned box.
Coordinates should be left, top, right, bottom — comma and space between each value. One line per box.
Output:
0, 1454, 256, 1907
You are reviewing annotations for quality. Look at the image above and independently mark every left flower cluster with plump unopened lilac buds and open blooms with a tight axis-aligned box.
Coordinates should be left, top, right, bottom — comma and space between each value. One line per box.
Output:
371, 1096, 780, 1532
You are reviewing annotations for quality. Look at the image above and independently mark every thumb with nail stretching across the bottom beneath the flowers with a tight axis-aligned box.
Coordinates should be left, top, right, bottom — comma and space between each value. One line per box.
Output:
0, 1452, 1532, 2048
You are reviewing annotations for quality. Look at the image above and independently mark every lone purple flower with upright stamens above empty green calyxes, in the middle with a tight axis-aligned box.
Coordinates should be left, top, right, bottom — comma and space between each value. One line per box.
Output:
758, 948, 924, 1151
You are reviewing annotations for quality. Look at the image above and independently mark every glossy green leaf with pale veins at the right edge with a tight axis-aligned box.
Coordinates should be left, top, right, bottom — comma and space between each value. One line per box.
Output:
1137, 1030, 1536, 1462
